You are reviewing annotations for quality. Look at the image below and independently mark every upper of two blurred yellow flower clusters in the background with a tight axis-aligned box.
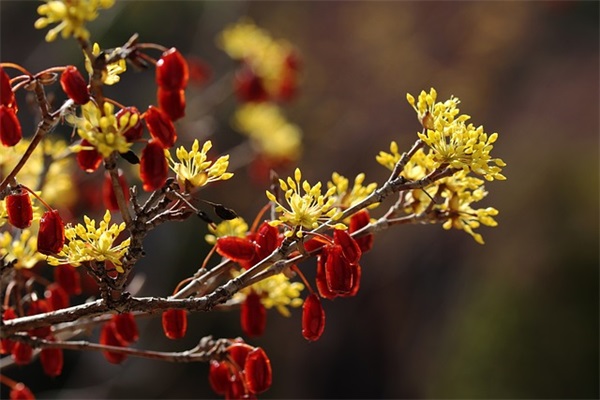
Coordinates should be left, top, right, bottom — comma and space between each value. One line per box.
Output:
217, 18, 292, 92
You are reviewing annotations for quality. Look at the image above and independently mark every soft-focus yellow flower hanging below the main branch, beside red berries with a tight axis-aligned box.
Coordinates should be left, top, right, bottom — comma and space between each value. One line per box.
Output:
234, 274, 304, 317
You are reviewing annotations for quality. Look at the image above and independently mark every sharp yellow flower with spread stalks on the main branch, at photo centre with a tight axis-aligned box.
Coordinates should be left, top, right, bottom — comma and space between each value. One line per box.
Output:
266, 168, 346, 237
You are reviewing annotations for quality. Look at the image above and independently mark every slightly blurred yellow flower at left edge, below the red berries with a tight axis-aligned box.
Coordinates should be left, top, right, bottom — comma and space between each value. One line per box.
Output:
0, 228, 44, 269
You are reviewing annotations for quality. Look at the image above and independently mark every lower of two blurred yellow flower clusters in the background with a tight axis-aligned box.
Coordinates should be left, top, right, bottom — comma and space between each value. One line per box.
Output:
233, 103, 302, 161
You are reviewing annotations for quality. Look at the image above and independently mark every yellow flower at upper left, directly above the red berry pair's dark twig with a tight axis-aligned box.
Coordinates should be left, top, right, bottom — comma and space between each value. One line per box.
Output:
67, 101, 137, 157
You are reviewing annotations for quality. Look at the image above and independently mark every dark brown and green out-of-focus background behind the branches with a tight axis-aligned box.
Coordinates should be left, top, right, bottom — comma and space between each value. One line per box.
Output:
0, 0, 599, 399
